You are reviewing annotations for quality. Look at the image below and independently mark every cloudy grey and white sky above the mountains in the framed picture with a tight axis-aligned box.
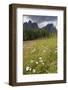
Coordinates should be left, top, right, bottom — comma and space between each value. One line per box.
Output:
23, 15, 57, 28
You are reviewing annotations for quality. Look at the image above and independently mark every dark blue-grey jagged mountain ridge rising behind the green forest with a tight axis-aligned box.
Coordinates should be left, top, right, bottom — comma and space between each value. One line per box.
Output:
23, 20, 57, 32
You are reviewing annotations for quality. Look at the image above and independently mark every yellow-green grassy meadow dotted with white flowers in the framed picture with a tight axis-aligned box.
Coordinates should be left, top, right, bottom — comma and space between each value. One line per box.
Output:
23, 36, 57, 74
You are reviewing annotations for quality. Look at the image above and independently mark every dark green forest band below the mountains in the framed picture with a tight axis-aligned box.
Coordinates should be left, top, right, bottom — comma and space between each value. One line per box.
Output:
23, 29, 55, 41
